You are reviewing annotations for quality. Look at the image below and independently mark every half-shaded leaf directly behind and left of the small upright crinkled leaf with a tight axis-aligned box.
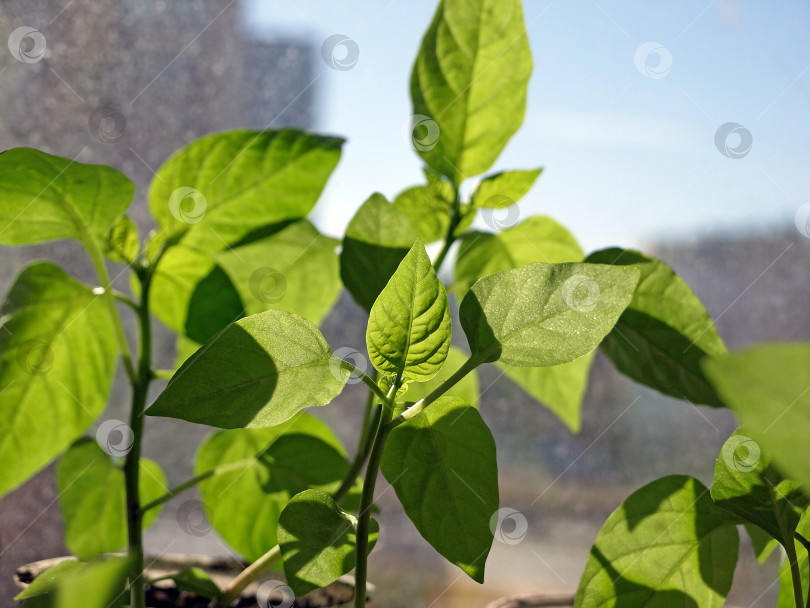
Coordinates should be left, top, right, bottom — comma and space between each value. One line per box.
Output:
340, 193, 418, 311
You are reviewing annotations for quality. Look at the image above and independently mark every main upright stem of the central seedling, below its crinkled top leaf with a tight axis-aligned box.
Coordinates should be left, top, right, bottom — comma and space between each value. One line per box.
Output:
354, 400, 396, 608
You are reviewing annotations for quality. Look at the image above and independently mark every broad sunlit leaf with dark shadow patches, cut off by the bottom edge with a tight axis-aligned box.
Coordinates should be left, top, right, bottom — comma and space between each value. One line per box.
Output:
574, 475, 739, 608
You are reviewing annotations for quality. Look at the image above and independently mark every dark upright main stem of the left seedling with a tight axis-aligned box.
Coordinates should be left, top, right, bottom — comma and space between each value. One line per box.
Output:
124, 272, 152, 608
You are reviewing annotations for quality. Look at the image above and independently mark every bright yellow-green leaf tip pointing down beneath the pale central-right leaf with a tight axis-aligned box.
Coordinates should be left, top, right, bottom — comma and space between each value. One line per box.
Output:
497, 351, 596, 433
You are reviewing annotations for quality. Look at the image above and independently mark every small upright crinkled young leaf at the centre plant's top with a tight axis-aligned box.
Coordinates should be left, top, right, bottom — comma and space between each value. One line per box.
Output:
366, 240, 450, 382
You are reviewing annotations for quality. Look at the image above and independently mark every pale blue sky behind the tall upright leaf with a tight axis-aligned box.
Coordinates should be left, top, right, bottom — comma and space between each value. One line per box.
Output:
242, 0, 810, 250
